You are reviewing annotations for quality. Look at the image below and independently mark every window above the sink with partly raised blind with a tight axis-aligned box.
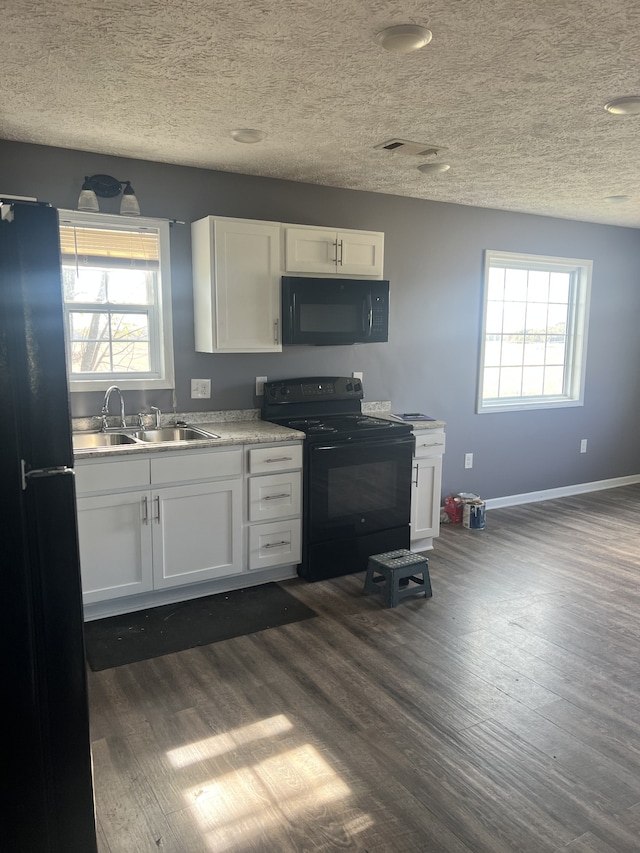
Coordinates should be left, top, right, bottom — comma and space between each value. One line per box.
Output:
60, 211, 173, 391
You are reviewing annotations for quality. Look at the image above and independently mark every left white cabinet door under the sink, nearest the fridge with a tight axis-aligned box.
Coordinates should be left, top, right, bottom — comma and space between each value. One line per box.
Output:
77, 491, 153, 604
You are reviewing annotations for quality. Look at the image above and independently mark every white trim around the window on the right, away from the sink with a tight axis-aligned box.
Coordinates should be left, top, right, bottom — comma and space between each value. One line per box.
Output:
476, 249, 593, 415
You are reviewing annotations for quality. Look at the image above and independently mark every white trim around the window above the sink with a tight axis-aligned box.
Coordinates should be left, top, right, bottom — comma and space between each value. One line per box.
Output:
58, 210, 175, 393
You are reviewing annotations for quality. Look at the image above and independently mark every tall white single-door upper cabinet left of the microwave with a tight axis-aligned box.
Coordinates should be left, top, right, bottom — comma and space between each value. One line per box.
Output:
191, 216, 282, 352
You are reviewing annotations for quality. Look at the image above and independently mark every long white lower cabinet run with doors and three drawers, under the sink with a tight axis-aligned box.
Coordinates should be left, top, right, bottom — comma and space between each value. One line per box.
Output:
75, 441, 302, 614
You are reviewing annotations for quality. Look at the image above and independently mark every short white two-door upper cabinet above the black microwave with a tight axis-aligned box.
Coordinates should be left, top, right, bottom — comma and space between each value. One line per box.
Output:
284, 225, 384, 278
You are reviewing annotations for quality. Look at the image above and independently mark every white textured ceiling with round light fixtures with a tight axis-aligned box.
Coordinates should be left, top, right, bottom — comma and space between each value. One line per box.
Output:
0, 0, 640, 227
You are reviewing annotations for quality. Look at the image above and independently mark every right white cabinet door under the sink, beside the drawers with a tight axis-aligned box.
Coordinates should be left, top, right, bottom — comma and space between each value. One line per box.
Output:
151, 479, 242, 589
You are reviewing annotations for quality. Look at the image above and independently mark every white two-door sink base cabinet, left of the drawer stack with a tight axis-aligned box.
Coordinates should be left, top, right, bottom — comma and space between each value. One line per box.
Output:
76, 448, 243, 604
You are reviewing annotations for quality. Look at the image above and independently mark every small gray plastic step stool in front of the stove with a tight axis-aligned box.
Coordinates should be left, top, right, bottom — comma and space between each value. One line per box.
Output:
364, 548, 433, 607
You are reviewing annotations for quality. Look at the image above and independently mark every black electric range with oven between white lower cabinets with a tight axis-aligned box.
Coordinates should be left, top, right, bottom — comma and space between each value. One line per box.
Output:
262, 376, 413, 581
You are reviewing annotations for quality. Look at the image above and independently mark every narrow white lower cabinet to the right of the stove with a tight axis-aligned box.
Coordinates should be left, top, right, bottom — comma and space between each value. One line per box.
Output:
411, 429, 445, 551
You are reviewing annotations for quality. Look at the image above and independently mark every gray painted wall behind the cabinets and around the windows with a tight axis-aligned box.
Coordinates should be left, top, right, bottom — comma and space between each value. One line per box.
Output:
0, 141, 640, 498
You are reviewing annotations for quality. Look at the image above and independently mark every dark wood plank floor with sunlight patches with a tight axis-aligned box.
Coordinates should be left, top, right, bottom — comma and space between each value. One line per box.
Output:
89, 485, 640, 853
